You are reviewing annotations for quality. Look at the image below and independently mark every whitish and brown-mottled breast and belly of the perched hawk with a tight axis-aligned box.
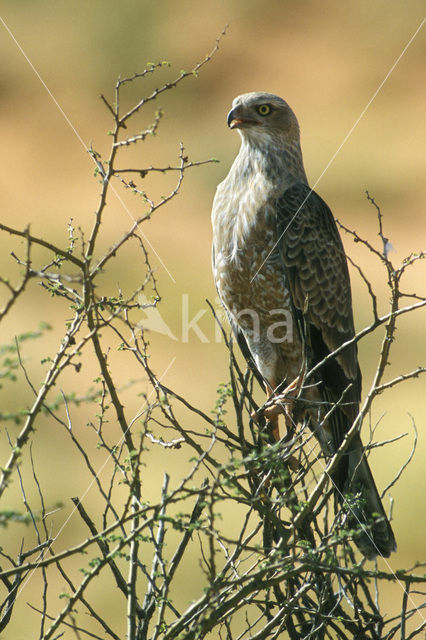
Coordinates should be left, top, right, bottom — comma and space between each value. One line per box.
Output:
213, 183, 302, 386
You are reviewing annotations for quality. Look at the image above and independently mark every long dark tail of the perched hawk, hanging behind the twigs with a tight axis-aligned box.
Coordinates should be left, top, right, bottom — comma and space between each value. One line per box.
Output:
344, 436, 396, 560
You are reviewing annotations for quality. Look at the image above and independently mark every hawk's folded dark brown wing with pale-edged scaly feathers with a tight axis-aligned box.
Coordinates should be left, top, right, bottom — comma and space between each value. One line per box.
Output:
277, 182, 361, 446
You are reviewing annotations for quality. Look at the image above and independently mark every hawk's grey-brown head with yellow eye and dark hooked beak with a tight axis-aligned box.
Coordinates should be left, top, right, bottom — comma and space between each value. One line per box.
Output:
228, 92, 300, 143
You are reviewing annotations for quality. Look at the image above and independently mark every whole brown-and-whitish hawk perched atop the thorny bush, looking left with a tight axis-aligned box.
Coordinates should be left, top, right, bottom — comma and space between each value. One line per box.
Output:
212, 93, 396, 559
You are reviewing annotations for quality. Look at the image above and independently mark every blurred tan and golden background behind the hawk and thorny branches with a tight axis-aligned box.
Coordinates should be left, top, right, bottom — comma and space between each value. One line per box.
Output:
0, 0, 426, 638
